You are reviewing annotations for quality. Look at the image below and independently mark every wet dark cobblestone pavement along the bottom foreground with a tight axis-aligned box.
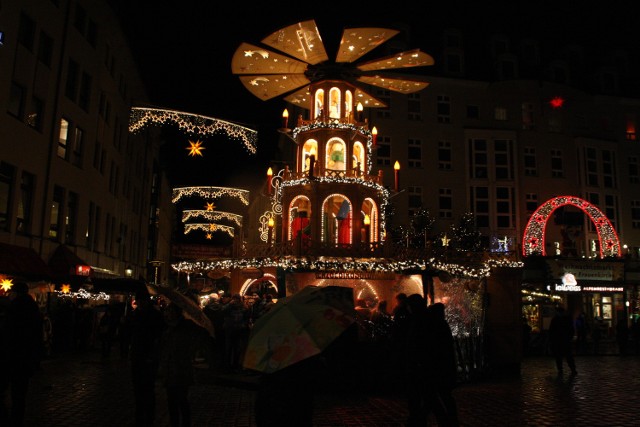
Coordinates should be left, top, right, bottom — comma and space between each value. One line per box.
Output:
21, 352, 640, 427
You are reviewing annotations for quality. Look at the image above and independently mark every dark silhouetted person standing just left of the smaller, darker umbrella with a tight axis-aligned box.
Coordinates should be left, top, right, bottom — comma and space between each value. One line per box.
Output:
129, 289, 164, 426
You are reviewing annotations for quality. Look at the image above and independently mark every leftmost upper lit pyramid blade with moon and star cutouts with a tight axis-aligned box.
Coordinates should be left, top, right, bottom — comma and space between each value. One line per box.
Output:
231, 43, 307, 75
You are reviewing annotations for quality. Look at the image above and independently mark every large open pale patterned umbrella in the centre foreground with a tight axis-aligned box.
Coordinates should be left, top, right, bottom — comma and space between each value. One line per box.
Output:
244, 286, 355, 373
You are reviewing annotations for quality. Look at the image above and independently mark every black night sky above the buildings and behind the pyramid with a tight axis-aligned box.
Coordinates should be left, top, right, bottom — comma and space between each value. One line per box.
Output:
111, 0, 639, 189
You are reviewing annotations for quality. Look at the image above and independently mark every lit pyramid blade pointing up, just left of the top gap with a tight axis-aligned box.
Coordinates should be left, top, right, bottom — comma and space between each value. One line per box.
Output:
262, 20, 329, 64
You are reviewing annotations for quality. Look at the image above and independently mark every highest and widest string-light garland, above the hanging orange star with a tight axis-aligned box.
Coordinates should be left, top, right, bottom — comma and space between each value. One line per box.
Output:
129, 107, 258, 154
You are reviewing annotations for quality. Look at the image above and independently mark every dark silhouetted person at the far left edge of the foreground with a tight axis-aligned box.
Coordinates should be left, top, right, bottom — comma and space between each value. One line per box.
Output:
0, 282, 44, 426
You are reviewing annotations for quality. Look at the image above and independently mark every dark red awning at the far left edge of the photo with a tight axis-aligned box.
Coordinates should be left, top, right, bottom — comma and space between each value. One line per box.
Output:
0, 243, 51, 280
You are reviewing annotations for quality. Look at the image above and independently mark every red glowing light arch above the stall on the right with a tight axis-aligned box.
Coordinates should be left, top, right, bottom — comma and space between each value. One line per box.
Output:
522, 196, 621, 258
